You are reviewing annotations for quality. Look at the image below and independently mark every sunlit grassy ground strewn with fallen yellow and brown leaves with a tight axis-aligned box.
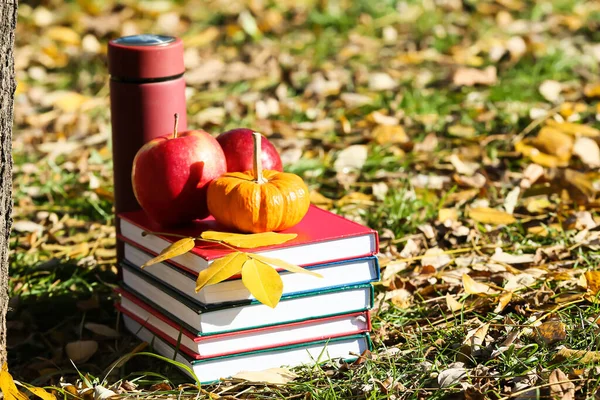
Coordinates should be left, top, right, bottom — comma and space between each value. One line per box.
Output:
9, 0, 600, 399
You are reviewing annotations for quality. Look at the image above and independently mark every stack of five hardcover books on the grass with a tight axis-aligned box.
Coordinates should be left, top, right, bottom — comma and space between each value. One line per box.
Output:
117, 206, 379, 383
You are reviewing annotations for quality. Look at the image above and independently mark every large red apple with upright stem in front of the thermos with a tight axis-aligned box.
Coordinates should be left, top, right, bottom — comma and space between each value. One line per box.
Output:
131, 116, 227, 226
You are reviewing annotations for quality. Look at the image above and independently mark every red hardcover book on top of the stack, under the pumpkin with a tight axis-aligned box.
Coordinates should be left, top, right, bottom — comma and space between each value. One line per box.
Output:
119, 205, 379, 273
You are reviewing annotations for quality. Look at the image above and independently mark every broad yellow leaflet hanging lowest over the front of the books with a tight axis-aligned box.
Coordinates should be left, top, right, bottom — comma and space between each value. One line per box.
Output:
242, 258, 283, 308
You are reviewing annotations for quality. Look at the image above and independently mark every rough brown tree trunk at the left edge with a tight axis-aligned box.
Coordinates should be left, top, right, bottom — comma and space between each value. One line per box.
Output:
0, 0, 17, 366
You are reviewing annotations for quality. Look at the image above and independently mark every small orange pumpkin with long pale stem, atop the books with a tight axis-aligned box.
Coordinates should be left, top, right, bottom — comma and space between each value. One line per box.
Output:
208, 132, 310, 233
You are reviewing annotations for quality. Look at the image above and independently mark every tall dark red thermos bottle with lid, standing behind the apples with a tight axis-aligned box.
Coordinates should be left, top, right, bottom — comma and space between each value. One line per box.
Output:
108, 35, 187, 216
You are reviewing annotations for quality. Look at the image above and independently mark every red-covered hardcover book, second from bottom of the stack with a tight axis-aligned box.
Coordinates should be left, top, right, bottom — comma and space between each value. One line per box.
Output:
115, 289, 371, 360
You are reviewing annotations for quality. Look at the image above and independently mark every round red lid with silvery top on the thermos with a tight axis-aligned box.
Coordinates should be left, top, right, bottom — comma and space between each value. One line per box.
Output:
108, 34, 185, 81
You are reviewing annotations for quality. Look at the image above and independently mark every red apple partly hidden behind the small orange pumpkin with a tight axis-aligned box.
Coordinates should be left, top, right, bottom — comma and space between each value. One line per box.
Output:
217, 128, 283, 172
